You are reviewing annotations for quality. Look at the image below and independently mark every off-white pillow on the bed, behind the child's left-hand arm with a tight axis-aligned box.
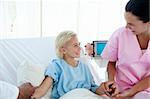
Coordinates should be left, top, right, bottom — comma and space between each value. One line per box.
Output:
17, 61, 51, 99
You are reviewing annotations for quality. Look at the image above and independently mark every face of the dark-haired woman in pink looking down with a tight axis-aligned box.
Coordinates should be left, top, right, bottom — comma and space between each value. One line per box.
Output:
125, 12, 150, 35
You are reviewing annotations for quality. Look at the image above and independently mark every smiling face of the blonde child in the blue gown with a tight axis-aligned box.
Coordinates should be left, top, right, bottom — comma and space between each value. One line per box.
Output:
63, 36, 81, 58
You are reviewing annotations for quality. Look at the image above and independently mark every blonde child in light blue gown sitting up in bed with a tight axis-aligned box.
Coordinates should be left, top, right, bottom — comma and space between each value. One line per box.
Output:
32, 31, 112, 99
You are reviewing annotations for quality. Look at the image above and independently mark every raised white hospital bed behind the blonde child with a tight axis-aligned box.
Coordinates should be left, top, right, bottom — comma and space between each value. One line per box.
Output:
0, 37, 107, 99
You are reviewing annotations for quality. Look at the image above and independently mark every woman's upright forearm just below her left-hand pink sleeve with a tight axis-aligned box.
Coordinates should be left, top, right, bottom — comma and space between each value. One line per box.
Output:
107, 61, 116, 81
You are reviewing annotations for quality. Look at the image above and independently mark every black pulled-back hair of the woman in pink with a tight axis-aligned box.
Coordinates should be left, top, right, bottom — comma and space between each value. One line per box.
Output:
125, 0, 150, 23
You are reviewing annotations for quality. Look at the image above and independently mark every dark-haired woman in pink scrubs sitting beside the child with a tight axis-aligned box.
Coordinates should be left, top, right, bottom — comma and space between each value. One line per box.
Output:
86, 0, 150, 99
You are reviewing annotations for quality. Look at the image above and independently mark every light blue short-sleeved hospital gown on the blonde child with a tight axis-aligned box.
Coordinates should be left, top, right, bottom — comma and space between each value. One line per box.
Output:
45, 59, 98, 99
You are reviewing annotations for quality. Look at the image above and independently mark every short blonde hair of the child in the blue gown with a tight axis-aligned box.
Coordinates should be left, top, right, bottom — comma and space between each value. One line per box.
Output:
55, 31, 76, 58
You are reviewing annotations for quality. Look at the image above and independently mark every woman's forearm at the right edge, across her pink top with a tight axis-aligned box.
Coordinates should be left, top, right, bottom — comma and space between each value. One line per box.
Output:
132, 76, 150, 93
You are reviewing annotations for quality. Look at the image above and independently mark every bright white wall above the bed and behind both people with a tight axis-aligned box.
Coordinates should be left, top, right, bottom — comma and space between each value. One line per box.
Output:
0, 0, 128, 42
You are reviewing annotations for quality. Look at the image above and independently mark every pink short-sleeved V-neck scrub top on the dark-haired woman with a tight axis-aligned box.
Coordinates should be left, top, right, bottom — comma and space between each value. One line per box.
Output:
102, 27, 150, 96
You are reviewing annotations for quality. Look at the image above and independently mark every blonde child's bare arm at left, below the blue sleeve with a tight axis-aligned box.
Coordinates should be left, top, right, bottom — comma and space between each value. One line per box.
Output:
31, 76, 53, 99
